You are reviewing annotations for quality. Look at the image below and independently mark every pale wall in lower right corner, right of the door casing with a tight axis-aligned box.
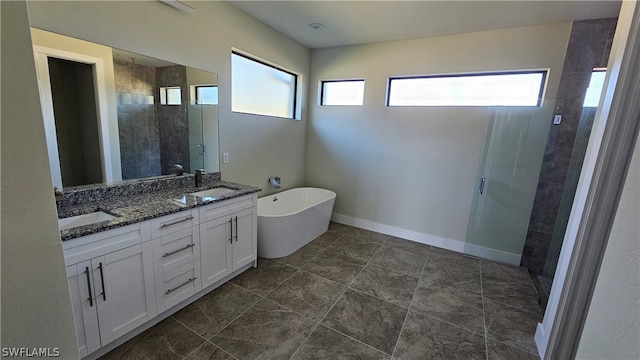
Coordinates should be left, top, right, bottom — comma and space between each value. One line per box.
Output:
577, 129, 640, 360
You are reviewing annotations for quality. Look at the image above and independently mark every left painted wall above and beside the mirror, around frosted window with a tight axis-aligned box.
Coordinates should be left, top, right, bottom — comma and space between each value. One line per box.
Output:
28, 1, 310, 195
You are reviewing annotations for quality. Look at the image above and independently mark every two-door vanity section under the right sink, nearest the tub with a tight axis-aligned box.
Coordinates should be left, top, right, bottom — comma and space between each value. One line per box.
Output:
200, 194, 257, 288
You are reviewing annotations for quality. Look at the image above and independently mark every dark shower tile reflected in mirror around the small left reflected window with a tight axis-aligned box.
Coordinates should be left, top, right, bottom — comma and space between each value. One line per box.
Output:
156, 65, 191, 175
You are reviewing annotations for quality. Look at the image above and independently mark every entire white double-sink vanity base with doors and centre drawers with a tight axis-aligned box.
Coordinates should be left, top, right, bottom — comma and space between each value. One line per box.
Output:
62, 193, 258, 357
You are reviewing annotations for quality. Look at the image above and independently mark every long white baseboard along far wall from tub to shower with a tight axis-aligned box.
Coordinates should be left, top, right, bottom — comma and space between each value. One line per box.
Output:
331, 213, 521, 266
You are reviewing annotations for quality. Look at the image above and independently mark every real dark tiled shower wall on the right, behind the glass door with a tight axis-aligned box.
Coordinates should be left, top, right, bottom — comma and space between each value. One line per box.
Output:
521, 18, 617, 274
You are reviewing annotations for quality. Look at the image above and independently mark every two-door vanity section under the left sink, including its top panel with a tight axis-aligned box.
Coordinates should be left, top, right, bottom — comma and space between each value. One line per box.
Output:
63, 223, 156, 356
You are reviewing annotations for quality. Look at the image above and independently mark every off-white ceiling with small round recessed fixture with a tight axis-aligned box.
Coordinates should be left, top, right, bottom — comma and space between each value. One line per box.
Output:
228, 0, 621, 49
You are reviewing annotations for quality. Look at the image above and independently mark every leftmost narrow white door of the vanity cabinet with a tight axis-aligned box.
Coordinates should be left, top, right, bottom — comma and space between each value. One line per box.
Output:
67, 261, 100, 357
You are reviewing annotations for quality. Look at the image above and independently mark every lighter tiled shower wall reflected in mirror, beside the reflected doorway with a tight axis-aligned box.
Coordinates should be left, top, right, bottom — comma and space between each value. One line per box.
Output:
113, 60, 161, 180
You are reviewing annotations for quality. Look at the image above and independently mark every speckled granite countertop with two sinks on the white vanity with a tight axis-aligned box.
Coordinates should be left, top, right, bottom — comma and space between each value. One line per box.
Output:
58, 179, 261, 241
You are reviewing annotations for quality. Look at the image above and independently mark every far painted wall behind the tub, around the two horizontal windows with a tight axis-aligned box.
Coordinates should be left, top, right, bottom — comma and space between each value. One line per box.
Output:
305, 23, 571, 250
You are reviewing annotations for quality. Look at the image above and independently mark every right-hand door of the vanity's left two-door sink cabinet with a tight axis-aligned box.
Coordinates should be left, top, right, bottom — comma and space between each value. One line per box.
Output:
91, 242, 156, 346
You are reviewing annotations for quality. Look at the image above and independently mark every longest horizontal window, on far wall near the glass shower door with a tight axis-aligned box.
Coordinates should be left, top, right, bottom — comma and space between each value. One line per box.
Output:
387, 70, 547, 106
